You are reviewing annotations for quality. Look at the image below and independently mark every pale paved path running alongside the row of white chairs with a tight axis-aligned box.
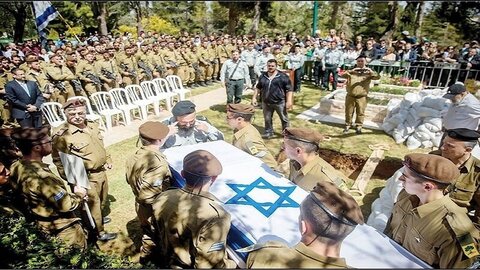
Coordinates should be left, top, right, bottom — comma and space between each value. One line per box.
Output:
104, 86, 227, 147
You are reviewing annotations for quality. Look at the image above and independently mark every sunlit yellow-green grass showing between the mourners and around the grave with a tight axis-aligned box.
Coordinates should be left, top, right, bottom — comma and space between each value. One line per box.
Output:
102, 80, 428, 260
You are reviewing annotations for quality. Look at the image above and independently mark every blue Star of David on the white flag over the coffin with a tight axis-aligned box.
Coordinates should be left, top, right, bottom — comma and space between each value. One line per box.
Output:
225, 177, 300, 217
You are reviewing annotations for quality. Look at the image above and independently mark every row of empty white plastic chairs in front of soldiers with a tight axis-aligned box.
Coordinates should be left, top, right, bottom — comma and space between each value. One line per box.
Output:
41, 75, 192, 130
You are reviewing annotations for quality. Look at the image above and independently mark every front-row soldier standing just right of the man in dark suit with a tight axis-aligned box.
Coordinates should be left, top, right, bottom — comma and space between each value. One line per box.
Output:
45, 54, 77, 104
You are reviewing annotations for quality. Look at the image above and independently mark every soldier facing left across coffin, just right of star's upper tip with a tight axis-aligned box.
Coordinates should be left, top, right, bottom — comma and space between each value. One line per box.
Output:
283, 128, 348, 191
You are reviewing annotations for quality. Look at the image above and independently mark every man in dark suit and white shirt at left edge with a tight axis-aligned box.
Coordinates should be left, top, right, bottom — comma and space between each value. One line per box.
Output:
5, 68, 45, 128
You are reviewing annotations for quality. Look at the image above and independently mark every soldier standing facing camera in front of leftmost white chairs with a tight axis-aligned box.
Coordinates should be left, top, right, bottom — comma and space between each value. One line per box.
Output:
52, 99, 117, 241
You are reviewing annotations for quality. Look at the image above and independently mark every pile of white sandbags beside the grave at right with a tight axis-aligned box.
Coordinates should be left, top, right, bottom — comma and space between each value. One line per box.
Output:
382, 89, 450, 149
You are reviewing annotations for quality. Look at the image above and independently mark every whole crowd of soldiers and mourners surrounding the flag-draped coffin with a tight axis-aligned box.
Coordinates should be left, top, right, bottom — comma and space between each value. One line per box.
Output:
0, 28, 480, 268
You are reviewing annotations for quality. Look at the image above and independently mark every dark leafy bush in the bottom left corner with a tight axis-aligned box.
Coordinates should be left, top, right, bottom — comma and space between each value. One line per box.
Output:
0, 214, 141, 269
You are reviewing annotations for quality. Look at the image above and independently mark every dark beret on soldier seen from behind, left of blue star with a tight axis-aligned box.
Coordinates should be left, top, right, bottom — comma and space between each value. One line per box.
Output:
183, 150, 222, 177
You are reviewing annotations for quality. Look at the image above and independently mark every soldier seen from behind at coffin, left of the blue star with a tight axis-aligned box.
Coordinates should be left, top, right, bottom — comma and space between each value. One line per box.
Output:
153, 150, 236, 268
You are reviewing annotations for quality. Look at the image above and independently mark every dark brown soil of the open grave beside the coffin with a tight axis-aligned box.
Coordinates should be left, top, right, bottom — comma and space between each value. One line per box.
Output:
320, 149, 402, 180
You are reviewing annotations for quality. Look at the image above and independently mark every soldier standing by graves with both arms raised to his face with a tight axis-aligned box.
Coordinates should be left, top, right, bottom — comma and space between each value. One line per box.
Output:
342, 55, 380, 134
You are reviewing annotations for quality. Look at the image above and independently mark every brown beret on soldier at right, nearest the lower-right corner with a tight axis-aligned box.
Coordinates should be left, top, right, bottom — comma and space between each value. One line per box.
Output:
403, 153, 460, 184
